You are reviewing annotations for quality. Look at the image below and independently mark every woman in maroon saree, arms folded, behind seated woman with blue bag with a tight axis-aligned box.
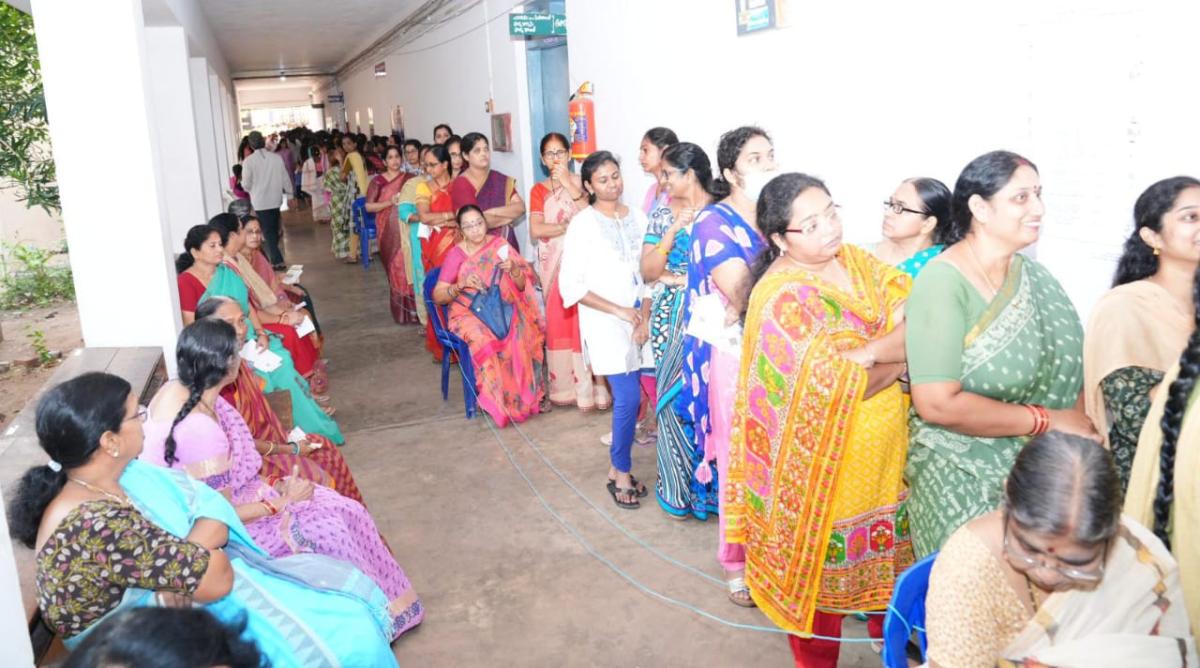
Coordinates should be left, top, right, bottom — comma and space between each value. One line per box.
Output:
450, 132, 524, 251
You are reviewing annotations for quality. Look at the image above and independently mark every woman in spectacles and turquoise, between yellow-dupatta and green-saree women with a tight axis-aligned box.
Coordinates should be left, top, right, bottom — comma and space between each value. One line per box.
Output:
871, 176, 950, 278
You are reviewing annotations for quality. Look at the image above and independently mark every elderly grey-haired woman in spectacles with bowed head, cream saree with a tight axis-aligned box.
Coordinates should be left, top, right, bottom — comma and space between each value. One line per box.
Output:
925, 432, 1196, 668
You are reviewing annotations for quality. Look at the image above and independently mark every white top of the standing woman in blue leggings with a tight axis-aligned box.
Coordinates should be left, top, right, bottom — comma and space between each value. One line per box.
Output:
558, 206, 647, 375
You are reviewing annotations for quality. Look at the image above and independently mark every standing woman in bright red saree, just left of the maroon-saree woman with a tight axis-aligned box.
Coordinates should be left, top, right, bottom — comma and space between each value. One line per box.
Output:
416, 145, 462, 362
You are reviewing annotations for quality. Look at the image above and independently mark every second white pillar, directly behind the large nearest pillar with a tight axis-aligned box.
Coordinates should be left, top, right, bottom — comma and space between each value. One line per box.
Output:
145, 26, 209, 252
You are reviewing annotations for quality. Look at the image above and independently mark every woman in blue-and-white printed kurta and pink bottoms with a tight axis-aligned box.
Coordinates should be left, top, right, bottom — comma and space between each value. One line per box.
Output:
678, 126, 775, 607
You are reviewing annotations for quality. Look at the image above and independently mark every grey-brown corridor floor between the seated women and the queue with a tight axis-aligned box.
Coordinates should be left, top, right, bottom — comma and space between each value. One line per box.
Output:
284, 210, 878, 668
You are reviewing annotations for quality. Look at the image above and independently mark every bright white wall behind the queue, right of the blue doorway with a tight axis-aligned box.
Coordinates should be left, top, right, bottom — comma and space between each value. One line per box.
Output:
566, 0, 1200, 317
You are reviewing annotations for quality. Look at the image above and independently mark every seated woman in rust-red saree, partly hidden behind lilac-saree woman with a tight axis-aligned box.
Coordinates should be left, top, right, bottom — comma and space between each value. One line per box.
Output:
196, 297, 362, 504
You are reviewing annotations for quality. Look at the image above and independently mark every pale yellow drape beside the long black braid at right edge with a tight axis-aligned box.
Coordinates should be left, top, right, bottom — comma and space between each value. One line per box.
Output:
1124, 365, 1200, 637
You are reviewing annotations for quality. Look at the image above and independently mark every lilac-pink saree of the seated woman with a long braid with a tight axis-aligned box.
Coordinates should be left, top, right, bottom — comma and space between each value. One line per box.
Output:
140, 398, 425, 638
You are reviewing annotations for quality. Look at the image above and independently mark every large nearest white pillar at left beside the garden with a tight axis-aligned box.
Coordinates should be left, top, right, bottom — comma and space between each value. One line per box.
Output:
32, 0, 181, 364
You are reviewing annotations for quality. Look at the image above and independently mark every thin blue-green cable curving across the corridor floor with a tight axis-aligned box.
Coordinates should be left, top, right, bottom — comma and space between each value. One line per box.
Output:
456, 357, 882, 643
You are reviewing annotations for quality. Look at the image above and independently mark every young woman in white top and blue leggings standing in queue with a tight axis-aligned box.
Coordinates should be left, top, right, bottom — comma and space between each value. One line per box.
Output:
558, 151, 649, 510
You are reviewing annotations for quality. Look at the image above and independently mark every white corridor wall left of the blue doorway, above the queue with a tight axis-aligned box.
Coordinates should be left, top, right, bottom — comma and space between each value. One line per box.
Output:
331, 1, 534, 251
